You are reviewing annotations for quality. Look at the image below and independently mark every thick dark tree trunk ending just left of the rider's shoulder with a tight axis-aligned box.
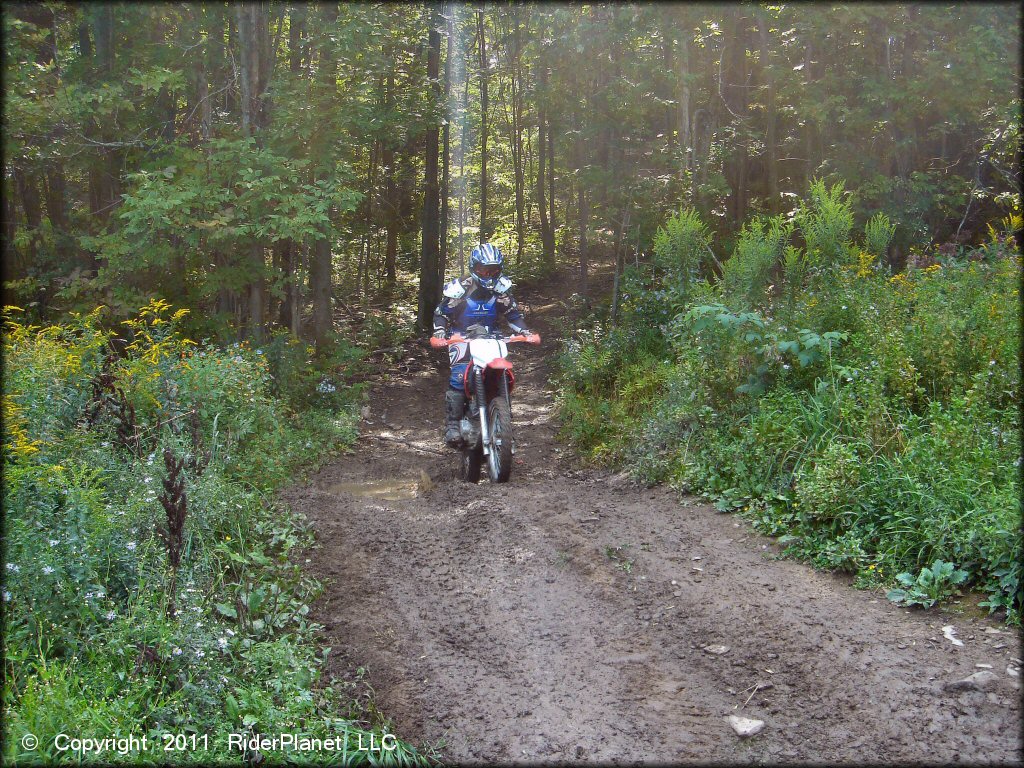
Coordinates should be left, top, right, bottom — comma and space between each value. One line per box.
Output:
417, 6, 442, 331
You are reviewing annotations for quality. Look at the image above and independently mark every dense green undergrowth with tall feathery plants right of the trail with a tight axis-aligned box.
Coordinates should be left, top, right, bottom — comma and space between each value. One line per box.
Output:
559, 183, 1024, 624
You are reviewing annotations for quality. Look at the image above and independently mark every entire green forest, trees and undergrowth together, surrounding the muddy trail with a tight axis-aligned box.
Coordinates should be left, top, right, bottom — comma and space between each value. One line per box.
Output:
2, 0, 1024, 763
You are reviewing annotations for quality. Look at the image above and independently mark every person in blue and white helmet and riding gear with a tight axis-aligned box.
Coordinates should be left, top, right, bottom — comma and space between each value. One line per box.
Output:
433, 243, 530, 447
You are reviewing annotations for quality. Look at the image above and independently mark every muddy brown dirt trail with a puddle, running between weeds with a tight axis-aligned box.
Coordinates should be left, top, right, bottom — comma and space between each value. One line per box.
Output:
284, 268, 1021, 764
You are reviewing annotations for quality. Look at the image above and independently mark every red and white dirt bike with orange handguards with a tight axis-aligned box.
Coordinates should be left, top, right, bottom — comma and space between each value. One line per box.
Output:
430, 331, 541, 482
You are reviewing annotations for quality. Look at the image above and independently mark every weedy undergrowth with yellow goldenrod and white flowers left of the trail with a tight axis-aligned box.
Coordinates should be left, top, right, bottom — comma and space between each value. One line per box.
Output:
3, 301, 423, 764
